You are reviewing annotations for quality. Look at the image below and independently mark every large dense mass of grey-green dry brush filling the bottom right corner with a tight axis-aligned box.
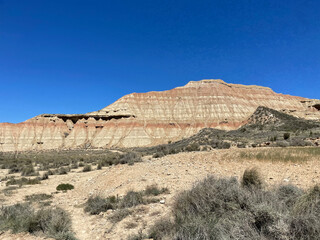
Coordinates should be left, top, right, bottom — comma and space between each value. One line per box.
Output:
139, 170, 320, 240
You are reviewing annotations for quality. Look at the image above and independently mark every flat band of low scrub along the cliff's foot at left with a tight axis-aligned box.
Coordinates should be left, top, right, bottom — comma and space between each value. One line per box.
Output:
0, 150, 141, 176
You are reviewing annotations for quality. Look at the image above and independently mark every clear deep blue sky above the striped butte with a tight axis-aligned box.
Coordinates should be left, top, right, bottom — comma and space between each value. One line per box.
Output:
0, 0, 320, 122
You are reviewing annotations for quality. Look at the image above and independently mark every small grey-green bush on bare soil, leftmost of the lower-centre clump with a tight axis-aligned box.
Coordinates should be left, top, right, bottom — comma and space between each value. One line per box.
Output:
84, 196, 118, 215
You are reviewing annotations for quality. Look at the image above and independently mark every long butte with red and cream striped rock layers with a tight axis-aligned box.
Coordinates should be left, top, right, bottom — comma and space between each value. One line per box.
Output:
0, 80, 320, 151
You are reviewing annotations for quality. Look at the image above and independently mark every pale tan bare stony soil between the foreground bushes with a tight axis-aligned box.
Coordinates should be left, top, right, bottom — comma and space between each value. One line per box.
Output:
0, 149, 320, 240
